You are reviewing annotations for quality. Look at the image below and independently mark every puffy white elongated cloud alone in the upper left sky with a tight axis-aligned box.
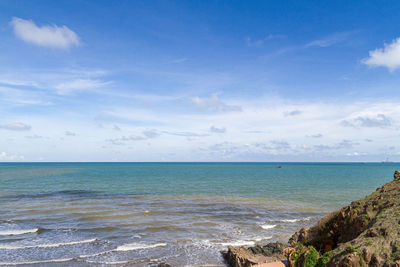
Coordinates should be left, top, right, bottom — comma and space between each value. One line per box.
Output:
11, 17, 79, 49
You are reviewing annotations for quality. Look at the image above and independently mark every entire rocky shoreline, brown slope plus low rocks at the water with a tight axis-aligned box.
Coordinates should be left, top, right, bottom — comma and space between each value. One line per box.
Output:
221, 171, 400, 267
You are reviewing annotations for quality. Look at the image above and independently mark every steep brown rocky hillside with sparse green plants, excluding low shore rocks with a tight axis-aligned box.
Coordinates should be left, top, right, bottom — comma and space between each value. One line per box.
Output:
287, 171, 400, 267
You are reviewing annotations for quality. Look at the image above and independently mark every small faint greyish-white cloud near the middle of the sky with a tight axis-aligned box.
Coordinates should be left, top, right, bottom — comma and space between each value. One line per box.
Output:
189, 94, 242, 112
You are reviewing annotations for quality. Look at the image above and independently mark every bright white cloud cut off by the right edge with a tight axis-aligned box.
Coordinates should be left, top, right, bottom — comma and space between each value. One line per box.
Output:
362, 37, 400, 71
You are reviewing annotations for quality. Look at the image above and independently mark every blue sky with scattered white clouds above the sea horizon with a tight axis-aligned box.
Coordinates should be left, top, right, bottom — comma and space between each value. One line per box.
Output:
0, 0, 400, 162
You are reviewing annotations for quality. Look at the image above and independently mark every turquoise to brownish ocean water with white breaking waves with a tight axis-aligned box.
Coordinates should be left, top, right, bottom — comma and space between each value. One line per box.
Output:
0, 163, 400, 266
